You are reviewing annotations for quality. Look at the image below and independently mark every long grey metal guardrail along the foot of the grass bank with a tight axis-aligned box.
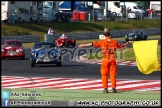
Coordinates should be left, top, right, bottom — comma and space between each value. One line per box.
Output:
1, 28, 161, 43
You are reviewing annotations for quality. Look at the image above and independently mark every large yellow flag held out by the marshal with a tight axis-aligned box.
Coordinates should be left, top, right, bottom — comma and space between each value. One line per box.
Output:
133, 40, 161, 74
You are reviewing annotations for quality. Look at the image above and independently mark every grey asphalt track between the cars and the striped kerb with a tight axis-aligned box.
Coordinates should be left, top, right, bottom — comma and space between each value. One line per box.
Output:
1, 39, 161, 80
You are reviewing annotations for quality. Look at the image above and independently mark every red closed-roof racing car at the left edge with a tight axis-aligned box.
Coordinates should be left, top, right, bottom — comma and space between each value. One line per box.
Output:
1, 40, 25, 59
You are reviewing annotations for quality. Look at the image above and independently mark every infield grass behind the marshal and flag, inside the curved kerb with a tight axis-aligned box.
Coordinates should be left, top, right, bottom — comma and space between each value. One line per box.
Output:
86, 45, 161, 61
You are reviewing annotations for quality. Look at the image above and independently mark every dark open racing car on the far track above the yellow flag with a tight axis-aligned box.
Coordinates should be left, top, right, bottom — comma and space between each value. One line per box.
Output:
125, 31, 148, 42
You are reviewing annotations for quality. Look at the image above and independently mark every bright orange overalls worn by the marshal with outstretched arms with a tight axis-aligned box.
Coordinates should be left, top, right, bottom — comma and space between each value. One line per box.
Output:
92, 37, 124, 88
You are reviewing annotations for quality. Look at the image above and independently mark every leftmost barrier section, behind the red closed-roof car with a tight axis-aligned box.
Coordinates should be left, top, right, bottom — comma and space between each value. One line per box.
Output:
1, 35, 40, 43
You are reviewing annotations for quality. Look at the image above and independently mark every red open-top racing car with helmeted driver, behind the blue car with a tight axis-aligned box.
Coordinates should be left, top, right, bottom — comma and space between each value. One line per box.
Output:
55, 34, 76, 47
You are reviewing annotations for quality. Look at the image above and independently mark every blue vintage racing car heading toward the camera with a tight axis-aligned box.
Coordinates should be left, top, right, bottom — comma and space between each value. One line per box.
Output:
30, 42, 62, 67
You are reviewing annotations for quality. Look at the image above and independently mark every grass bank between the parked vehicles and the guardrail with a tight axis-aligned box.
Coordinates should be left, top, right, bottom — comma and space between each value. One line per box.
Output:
1, 20, 161, 40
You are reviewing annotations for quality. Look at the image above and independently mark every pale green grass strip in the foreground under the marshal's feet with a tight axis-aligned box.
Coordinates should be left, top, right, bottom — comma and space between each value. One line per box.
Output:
2, 89, 161, 105
